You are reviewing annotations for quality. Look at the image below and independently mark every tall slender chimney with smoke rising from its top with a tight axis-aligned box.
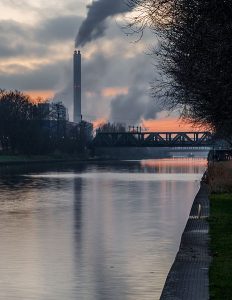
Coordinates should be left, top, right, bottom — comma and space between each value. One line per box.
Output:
73, 50, 82, 123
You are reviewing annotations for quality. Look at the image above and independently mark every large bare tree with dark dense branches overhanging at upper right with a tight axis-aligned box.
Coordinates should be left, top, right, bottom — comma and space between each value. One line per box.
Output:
128, 0, 232, 141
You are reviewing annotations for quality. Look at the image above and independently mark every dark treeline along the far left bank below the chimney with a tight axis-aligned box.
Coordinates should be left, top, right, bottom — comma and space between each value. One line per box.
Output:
0, 90, 93, 155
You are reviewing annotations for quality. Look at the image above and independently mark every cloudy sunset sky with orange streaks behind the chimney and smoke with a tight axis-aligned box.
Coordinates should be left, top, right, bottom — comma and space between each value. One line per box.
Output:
0, 0, 192, 130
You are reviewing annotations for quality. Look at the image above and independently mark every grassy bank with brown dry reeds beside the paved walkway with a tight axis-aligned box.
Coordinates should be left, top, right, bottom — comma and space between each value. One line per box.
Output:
208, 161, 232, 300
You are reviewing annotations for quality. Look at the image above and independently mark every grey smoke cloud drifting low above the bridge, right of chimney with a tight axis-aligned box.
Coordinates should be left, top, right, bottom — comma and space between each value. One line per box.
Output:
110, 50, 163, 125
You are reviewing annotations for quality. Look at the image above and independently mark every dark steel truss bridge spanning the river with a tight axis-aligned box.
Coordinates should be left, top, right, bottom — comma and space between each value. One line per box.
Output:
91, 131, 213, 148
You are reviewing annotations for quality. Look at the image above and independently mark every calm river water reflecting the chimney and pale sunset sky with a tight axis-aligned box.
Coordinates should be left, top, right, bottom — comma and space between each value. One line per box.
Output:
0, 159, 206, 300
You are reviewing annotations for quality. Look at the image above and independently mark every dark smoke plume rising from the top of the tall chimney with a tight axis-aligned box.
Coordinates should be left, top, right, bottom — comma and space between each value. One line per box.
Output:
76, 0, 133, 47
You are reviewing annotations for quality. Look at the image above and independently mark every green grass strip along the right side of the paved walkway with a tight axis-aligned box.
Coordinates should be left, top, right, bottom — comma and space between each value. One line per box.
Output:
209, 194, 232, 300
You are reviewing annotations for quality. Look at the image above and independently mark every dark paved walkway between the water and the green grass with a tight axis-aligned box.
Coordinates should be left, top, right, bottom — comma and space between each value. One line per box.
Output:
160, 183, 211, 300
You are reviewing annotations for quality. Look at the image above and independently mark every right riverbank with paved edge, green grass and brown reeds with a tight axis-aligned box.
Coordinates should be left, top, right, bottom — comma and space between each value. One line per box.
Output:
160, 161, 232, 300
